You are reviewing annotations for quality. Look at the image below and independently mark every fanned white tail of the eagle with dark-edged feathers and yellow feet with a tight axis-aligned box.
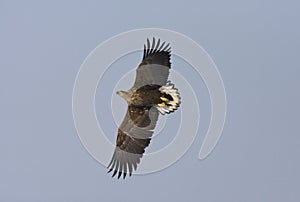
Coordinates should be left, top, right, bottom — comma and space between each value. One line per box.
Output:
157, 81, 181, 114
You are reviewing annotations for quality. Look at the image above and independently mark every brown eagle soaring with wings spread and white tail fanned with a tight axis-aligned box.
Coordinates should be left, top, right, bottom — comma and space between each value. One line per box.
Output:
107, 38, 181, 179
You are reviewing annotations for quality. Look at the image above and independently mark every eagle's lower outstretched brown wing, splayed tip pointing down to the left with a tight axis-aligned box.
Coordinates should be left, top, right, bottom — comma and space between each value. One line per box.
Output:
108, 106, 159, 179
